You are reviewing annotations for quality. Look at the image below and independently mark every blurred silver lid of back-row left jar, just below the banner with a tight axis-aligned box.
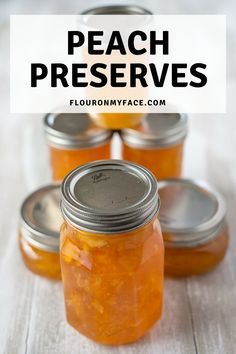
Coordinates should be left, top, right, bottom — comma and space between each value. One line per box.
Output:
44, 113, 112, 149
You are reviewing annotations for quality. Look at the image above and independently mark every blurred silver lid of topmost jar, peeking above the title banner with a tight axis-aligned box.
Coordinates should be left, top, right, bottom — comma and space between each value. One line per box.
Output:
82, 5, 152, 15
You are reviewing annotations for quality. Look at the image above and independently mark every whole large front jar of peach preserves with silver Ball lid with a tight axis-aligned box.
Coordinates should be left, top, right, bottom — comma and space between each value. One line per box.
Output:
60, 160, 164, 344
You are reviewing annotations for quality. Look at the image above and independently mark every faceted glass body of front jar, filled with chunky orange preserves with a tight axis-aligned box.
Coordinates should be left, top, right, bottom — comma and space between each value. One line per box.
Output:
61, 217, 164, 344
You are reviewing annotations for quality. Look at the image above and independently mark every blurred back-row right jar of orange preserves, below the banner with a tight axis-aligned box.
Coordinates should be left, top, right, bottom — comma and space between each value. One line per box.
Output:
121, 113, 187, 180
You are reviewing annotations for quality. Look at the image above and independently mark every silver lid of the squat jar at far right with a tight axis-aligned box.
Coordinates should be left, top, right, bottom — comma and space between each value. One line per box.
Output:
159, 179, 226, 247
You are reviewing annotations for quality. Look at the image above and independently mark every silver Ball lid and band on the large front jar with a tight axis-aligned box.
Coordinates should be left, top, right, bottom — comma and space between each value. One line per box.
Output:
61, 160, 159, 234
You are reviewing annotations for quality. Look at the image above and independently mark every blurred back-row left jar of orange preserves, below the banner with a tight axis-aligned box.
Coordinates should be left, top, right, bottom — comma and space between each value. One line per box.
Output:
44, 113, 112, 181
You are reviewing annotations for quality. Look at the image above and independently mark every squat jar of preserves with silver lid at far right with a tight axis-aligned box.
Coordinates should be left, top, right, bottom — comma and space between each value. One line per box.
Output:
159, 179, 229, 277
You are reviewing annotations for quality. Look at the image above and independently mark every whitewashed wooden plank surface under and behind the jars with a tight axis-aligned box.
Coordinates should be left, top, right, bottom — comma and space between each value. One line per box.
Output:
0, 1, 236, 354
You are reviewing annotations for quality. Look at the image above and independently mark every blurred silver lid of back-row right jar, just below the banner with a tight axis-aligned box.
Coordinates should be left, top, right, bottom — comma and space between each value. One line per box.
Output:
121, 113, 187, 149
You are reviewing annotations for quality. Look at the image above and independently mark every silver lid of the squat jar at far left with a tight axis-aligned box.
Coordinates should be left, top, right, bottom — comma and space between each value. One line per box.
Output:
20, 185, 63, 253
